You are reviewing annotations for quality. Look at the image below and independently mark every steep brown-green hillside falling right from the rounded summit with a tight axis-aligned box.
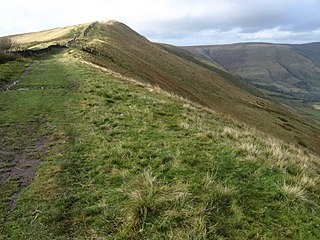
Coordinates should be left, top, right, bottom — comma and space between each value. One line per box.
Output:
62, 21, 320, 156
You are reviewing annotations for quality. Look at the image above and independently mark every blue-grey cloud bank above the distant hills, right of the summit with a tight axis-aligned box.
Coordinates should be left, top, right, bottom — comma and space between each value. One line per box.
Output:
140, 0, 320, 45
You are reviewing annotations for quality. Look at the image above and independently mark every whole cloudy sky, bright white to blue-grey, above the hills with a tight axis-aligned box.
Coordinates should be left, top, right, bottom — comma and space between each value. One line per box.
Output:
0, 0, 320, 45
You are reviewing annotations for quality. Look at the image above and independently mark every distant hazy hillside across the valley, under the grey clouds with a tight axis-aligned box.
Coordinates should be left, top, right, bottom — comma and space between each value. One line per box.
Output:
185, 43, 320, 120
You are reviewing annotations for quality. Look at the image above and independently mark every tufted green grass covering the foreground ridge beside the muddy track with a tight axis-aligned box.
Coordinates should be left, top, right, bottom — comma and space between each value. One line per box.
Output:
0, 50, 320, 239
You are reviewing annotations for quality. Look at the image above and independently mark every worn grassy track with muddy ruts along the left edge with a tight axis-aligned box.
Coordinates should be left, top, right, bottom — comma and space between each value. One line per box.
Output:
0, 52, 70, 227
